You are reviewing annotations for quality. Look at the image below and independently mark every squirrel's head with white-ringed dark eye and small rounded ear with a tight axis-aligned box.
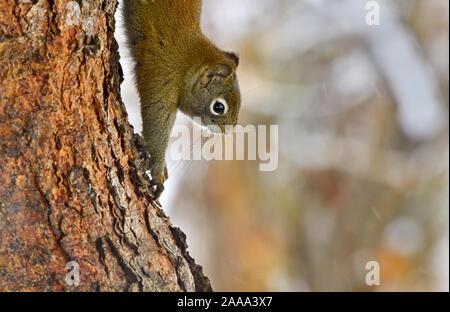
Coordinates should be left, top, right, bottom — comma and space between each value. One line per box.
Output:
179, 52, 241, 132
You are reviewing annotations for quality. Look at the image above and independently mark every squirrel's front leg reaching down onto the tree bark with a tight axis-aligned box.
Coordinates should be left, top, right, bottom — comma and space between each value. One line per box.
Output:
141, 97, 177, 199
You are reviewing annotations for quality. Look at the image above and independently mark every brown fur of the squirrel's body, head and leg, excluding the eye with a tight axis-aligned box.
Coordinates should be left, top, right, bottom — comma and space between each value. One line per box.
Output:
123, 0, 240, 196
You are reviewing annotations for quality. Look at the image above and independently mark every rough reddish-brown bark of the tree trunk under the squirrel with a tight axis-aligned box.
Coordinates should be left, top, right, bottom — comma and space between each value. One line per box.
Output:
0, 0, 211, 291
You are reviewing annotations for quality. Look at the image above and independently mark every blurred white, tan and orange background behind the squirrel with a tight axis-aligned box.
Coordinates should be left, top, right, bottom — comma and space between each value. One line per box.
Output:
116, 0, 449, 291
